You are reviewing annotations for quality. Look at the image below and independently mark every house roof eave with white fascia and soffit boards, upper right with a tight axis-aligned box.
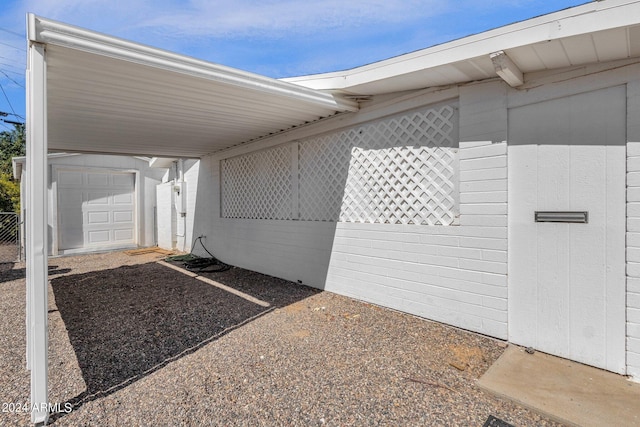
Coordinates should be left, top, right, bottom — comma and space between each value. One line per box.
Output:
283, 0, 640, 95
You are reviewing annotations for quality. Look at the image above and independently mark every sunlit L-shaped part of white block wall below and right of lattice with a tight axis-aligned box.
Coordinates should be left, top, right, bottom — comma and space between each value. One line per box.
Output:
325, 141, 507, 338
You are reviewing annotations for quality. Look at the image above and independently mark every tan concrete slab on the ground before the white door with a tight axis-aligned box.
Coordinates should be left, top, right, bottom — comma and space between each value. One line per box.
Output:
478, 345, 640, 427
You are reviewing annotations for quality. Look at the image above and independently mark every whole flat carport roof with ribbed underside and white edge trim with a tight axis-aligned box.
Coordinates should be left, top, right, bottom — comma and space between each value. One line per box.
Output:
28, 14, 358, 157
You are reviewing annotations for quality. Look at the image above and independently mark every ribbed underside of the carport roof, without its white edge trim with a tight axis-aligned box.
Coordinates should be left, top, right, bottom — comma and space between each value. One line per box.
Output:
47, 47, 344, 157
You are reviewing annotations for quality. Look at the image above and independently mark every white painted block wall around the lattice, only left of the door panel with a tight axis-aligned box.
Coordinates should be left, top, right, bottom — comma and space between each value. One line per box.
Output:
196, 83, 507, 338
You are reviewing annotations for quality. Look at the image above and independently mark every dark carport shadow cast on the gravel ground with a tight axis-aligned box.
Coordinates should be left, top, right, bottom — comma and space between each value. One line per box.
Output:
51, 263, 320, 420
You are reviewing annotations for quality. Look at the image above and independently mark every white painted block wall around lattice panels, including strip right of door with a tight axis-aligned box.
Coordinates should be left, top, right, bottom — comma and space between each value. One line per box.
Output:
195, 64, 640, 379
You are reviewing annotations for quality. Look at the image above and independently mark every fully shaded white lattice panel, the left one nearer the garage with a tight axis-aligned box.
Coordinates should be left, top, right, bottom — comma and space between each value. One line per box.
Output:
221, 145, 294, 219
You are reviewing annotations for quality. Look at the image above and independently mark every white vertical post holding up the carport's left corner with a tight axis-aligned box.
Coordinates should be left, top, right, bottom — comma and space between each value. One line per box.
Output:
26, 37, 49, 424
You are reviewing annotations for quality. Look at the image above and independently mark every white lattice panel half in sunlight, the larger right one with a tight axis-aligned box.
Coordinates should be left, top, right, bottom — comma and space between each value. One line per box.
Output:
299, 105, 458, 225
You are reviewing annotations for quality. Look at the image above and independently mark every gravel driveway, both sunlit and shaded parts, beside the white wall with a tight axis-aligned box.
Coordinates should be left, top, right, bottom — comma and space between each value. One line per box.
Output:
0, 252, 558, 426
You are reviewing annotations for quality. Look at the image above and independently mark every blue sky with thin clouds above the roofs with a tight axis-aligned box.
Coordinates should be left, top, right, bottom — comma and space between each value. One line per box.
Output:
0, 0, 588, 130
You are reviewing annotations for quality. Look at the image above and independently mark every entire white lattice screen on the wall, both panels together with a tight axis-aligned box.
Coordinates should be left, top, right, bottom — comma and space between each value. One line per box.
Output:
221, 104, 458, 225
